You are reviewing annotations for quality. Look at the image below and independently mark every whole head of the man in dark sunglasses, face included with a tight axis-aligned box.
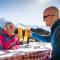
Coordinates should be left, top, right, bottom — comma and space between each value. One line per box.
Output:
43, 6, 59, 26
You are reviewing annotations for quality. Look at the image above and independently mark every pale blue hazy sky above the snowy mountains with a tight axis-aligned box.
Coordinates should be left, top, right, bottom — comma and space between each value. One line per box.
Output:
0, 0, 60, 26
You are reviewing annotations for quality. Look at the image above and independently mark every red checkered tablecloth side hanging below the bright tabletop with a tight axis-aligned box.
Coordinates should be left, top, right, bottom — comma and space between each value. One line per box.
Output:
0, 50, 51, 60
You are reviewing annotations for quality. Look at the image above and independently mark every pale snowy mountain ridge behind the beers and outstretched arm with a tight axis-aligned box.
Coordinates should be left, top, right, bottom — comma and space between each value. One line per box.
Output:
16, 23, 51, 32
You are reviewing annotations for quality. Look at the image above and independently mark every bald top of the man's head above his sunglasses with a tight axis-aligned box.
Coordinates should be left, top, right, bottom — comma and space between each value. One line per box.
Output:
44, 6, 59, 17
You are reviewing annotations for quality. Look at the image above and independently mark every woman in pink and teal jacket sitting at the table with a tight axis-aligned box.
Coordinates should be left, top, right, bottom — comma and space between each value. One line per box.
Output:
0, 22, 20, 49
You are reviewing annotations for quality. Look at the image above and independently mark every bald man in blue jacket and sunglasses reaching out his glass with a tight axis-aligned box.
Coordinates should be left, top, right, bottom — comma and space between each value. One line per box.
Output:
32, 6, 60, 60
